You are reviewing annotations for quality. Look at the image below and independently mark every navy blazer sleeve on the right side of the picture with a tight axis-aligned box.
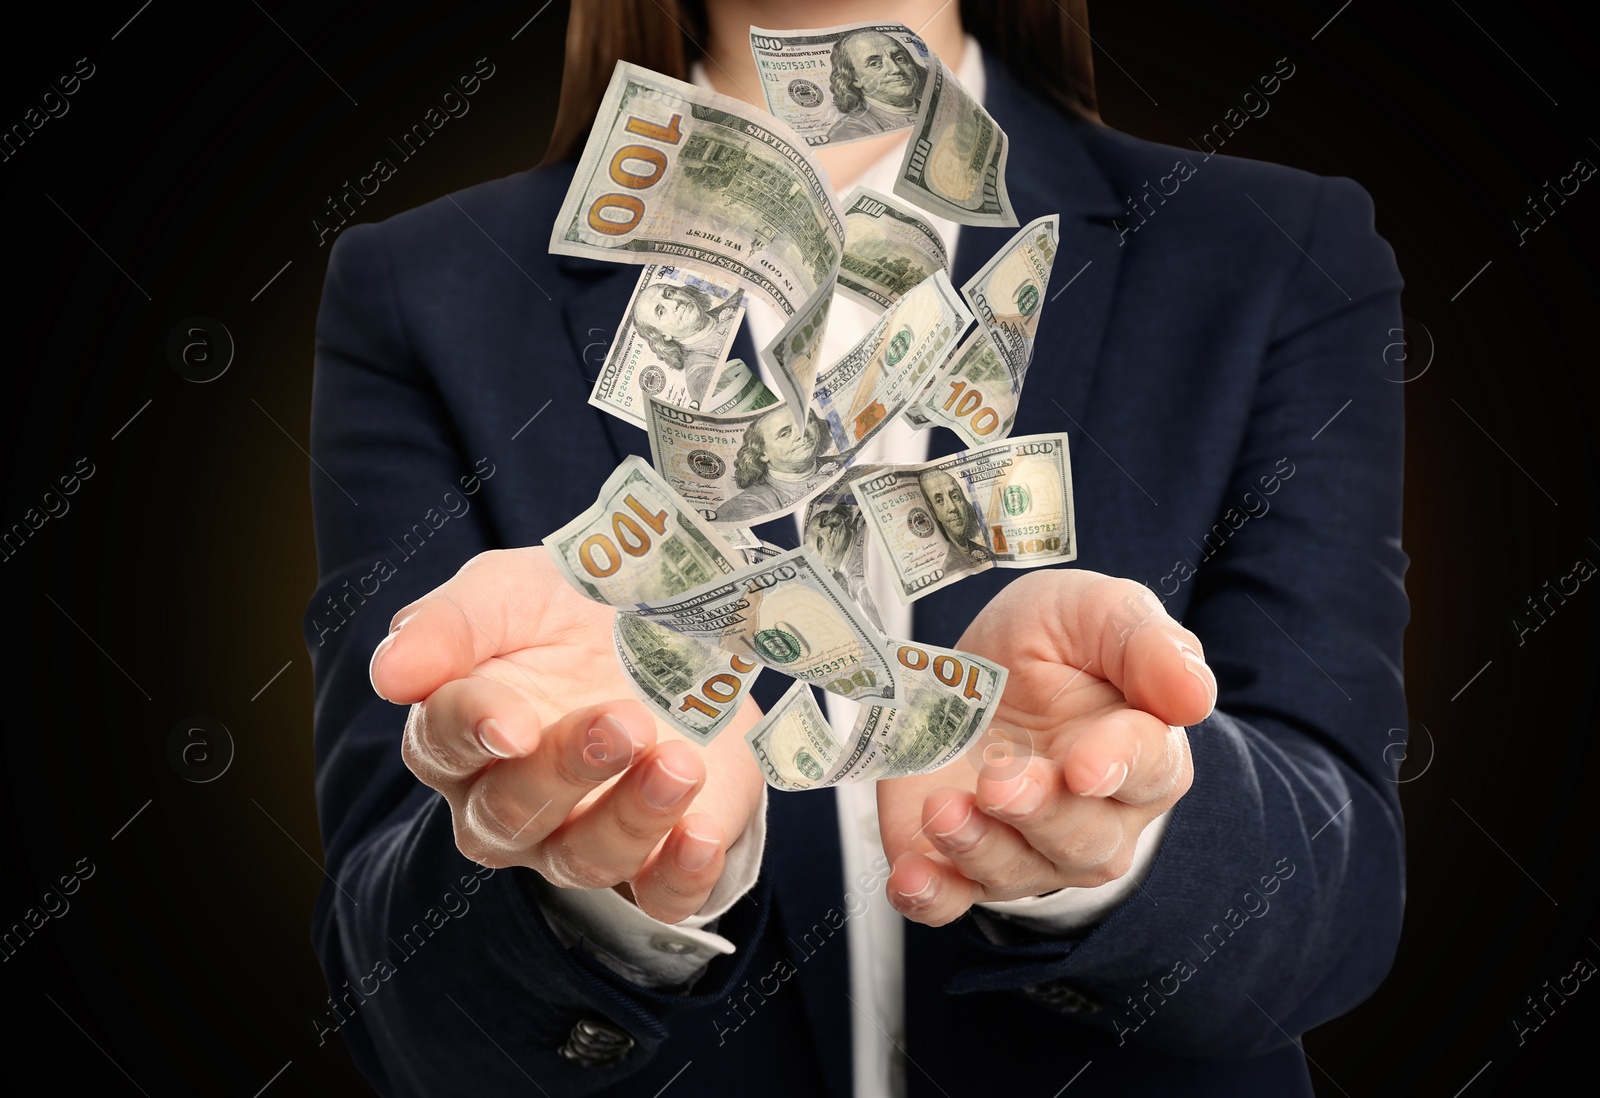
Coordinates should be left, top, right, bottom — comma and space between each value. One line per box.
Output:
954, 178, 1410, 1058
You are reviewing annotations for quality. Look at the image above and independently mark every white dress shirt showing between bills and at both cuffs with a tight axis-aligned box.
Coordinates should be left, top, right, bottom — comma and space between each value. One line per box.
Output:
539, 37, 1166, 1098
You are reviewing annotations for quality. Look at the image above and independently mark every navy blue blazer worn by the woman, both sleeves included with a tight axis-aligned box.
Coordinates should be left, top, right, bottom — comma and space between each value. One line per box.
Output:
306, 64, 1408, 1098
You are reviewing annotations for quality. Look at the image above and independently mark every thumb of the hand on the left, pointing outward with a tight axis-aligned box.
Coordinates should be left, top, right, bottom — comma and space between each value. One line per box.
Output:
368, 546, 611, 704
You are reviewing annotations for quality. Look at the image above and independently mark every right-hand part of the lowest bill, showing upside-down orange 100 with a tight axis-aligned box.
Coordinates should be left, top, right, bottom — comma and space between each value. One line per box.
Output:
827, 640, 1006, 784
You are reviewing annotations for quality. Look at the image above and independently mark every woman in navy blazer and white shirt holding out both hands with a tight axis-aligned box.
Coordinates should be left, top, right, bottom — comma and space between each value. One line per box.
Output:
307, 0, 1406, 1096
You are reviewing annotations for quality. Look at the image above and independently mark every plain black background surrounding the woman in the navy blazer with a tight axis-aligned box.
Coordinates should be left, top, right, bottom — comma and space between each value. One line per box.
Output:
0, 0, 1600, 1098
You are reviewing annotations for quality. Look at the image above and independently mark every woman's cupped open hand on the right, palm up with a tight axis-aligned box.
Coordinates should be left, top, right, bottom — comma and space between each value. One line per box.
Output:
878, 570, 1216, 927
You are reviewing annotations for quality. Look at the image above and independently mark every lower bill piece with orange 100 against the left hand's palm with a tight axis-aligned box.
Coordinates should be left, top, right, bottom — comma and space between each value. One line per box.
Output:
611, 613, 762, 746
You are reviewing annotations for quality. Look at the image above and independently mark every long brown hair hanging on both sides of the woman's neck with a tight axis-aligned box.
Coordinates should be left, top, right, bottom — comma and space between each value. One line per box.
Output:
544, 0, 1101, 163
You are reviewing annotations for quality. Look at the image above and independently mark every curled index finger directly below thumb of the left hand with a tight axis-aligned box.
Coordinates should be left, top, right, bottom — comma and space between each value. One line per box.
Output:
400, 677, 539, 789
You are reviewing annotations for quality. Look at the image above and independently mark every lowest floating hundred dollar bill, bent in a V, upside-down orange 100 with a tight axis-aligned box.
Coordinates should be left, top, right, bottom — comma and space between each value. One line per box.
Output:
744, 640, 1006, 791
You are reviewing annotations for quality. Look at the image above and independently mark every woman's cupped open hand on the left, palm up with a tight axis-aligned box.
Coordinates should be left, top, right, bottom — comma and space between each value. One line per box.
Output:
371, 547, 763, 922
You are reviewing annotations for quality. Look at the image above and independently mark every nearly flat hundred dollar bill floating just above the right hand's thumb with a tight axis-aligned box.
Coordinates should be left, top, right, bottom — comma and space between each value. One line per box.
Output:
851, 434, 1078, 605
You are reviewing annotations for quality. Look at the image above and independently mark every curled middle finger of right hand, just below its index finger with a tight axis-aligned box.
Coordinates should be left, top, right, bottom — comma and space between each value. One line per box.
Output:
976, 759, 1144, 895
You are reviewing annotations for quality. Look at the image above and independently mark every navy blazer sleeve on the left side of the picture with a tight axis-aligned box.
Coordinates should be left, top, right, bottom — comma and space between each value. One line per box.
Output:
304, 226, 770, 1098
